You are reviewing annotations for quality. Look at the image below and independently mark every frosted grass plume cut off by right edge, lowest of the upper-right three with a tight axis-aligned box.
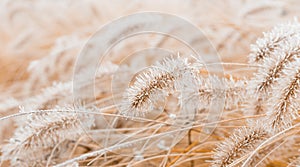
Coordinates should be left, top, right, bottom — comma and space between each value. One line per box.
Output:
267, 63, 300, 132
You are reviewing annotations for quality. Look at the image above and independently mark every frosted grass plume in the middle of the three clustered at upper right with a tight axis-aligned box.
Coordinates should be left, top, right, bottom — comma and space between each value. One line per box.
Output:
247, 28, 300, 114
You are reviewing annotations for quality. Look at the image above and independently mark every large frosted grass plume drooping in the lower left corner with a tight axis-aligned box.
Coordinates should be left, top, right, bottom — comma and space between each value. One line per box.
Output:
2, 107, 94, 166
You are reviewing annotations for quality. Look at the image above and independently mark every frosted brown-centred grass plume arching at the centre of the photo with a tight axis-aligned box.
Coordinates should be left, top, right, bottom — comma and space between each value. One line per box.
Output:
120, 58, 188, 117
